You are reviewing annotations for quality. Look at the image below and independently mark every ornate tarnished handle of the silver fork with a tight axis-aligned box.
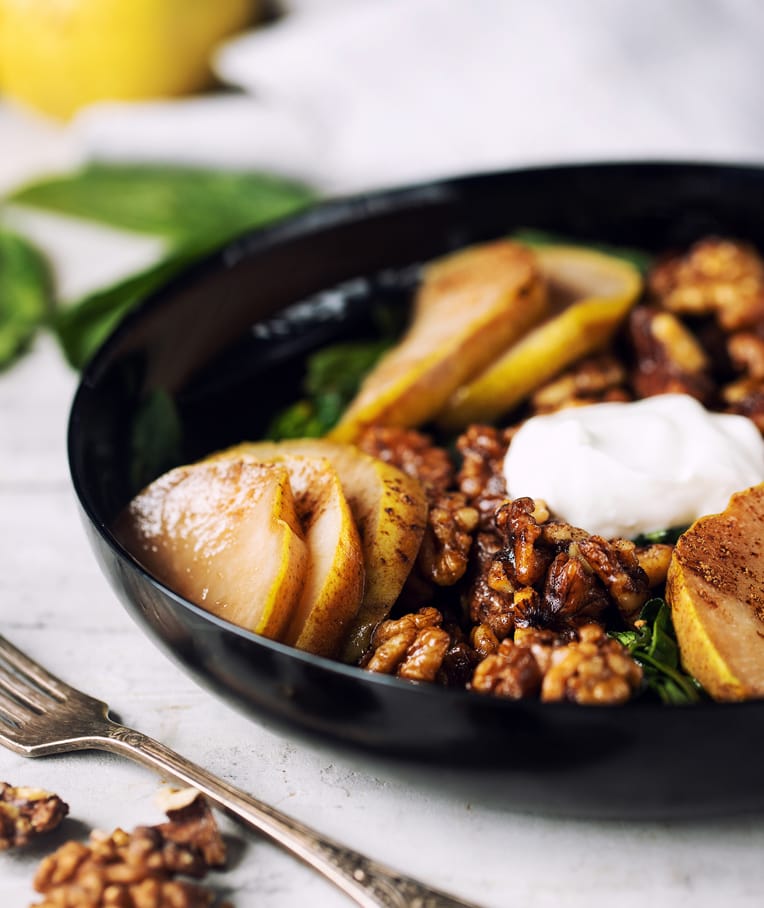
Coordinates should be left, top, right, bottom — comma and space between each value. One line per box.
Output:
89, 720, 477, 908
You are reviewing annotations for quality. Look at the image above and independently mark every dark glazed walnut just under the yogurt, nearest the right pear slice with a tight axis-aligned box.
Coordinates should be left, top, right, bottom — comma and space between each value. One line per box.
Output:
577, 536, 650, 622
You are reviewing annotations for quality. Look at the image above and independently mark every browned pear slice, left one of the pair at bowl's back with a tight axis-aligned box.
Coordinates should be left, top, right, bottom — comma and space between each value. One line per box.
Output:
329, 240, 546, 442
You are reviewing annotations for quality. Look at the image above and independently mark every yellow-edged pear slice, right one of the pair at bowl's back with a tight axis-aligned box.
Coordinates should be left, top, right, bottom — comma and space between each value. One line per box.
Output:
438, 246, 642, 430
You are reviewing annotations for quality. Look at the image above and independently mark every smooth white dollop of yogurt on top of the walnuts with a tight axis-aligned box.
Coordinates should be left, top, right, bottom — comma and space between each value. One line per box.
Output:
504, 394, 764, 539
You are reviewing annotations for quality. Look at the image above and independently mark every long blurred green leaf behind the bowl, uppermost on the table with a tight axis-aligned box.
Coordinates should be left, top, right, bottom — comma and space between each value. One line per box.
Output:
10, 164, 315, 244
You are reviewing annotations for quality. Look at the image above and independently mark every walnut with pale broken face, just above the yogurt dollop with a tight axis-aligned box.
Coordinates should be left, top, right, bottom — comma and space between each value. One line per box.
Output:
629, 306, 715, 403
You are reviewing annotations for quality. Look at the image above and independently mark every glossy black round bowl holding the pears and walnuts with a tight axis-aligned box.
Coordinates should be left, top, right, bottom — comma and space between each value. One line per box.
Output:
64, 163, 764, 818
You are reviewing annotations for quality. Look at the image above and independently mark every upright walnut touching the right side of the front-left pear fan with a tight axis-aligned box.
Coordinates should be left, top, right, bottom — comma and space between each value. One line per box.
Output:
417, 492, 478, 586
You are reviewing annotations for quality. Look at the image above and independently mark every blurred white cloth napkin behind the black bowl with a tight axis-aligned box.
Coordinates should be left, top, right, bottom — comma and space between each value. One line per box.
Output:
74, 0, 764, 191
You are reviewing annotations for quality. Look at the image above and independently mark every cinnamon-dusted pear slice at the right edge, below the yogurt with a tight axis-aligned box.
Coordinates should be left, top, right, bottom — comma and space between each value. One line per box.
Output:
666, 483, 764, 700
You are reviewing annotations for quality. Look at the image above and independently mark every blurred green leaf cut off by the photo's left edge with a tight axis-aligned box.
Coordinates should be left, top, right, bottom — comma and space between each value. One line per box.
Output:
0, 229, 51, 369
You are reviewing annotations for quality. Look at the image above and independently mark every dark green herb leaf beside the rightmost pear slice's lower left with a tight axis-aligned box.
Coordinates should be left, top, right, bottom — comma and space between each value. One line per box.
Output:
611, 598, 702, 706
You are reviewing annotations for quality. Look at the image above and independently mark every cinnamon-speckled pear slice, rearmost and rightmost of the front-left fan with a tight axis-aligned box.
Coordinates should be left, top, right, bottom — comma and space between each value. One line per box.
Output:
213, 438, 427, 662
